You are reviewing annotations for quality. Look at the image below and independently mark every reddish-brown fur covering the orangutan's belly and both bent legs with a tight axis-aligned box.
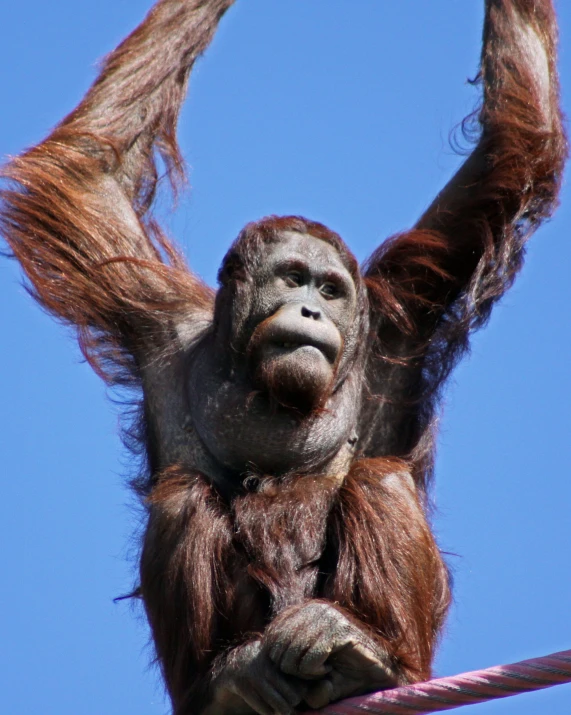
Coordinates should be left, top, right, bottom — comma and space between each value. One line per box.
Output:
141, 459, 449, 713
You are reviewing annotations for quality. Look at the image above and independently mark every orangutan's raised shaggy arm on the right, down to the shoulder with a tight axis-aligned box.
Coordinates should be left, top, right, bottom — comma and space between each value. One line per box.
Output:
367, 0, 567, 352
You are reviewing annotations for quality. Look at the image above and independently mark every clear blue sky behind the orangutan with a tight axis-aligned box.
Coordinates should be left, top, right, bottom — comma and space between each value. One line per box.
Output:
0, 0, 571, 715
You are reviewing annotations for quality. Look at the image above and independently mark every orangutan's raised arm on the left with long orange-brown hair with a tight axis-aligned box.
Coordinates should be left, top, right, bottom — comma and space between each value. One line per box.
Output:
0, 0, 221, 372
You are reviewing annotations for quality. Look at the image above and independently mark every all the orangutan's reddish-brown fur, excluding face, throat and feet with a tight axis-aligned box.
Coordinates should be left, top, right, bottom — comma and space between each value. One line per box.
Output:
0, 0, 566, 715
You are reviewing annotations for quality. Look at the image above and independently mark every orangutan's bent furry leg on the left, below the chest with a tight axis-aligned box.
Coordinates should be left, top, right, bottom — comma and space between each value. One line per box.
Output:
140, 467, 232, 715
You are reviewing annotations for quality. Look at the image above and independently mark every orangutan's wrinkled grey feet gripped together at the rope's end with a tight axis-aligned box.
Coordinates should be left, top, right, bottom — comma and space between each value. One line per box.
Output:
205, 601, 397, 715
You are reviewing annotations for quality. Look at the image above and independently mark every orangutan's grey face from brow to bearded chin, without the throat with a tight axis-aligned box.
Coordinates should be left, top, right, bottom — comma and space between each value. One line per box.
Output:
248, 232, 356, 413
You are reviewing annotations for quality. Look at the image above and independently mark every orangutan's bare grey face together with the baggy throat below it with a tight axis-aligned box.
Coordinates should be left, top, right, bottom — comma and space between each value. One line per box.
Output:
189, 232, 366, 484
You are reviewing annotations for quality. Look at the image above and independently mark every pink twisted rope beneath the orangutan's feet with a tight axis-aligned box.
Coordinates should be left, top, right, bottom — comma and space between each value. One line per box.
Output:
312, 650, 571, 715
